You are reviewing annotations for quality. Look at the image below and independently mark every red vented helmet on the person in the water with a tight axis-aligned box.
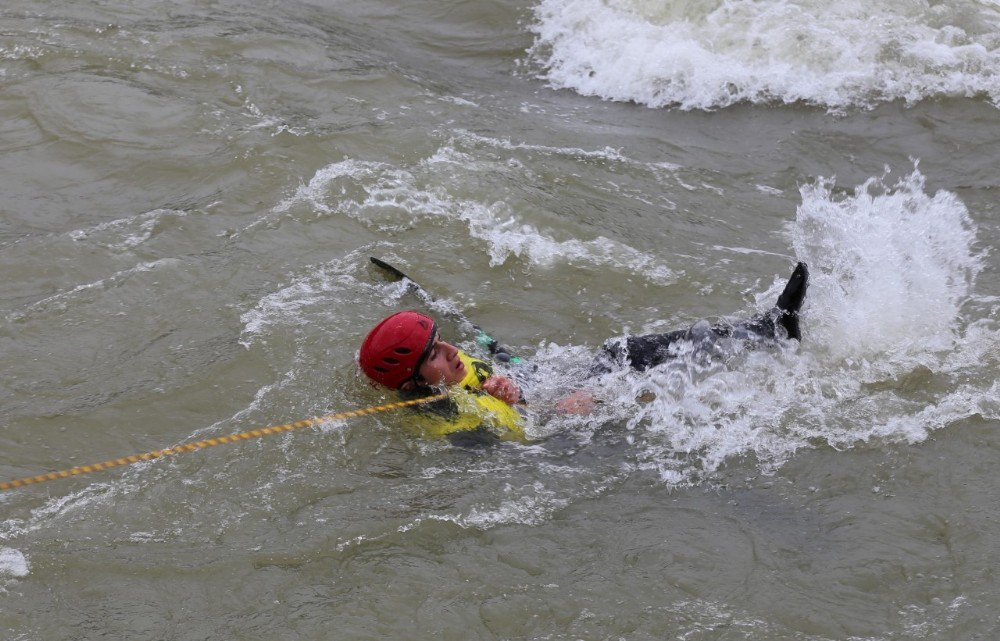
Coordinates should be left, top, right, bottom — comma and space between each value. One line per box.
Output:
358, 312, 437, 389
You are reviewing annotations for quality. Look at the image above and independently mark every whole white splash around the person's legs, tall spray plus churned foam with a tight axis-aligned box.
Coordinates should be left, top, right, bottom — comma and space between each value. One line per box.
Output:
539, 170, 988, 485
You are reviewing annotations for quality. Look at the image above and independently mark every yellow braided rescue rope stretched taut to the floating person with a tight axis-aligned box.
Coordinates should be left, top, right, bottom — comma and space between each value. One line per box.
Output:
0, 393, 448, 491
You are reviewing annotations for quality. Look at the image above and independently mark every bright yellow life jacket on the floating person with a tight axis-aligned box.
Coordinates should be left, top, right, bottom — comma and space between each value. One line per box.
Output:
407, 350, 526, 441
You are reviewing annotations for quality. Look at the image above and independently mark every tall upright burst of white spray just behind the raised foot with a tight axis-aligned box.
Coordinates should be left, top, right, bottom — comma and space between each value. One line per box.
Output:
792, 170, 982, 369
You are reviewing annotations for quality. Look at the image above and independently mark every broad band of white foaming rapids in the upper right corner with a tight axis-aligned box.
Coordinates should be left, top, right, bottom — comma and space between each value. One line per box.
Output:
529, 0, 1000, 109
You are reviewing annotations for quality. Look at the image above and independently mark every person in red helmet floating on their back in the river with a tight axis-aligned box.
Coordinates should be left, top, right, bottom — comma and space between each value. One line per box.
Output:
358, 263, 809, 444
